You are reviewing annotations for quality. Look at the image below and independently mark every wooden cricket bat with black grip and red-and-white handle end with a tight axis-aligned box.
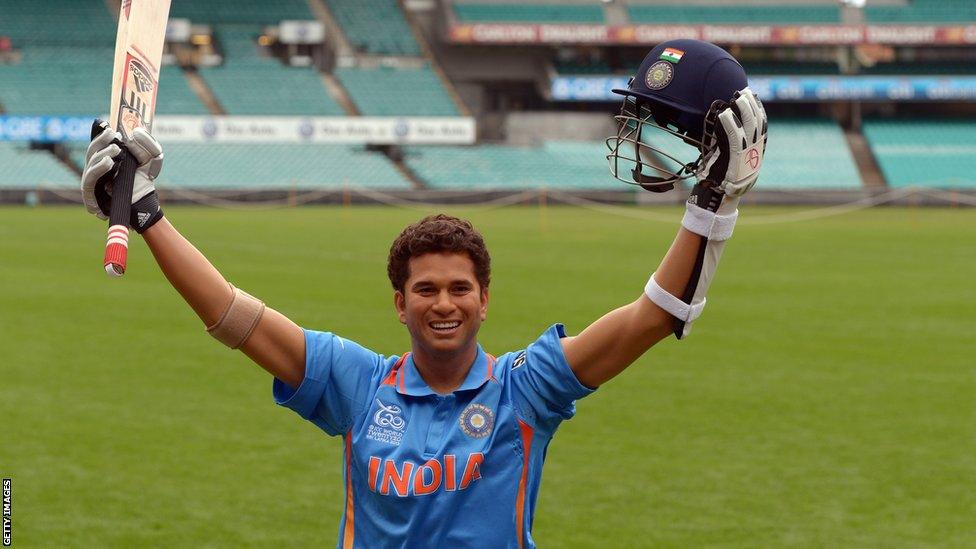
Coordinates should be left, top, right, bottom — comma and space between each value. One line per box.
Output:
103, 0, 170, 277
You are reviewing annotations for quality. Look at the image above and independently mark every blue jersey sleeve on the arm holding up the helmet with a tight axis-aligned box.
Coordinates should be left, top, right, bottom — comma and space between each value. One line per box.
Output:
511, 324, 595, 434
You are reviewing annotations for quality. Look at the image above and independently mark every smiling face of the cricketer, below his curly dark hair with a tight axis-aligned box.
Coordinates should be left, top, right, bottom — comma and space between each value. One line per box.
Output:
394, 253, 488, 364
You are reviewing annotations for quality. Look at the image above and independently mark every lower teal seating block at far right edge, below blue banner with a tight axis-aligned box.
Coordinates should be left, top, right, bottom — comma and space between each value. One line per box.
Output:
863, 119, 976, 188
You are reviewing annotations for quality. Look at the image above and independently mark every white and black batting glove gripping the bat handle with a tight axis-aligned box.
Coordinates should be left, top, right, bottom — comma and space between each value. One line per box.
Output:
81, 120, 163, 234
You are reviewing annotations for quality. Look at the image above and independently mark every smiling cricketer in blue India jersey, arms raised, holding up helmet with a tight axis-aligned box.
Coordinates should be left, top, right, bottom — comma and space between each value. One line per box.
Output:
82, 40, 766, 547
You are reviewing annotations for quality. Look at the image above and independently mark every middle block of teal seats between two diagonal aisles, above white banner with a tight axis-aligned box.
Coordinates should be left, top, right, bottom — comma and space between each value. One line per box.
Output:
200, 25, 345, 116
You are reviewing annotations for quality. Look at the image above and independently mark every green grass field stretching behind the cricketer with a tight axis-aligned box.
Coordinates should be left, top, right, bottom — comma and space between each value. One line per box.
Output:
0, 203, 976, 547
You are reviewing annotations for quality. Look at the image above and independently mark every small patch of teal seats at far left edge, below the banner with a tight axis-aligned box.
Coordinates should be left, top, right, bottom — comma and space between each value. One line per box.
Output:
0, 141, 78, 189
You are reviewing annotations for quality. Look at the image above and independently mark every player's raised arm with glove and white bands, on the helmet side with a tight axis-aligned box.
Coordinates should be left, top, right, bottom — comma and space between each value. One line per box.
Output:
562, 88, 766, 387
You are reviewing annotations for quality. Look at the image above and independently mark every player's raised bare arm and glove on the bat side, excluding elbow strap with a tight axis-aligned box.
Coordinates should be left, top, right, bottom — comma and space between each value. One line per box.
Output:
82, 121, 305, 388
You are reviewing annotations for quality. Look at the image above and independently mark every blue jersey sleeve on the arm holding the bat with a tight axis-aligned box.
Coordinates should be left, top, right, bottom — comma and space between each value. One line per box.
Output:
272, 330, 384, 436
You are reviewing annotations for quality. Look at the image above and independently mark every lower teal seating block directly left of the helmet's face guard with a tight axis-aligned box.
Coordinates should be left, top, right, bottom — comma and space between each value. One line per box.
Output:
405, 141, 622, 190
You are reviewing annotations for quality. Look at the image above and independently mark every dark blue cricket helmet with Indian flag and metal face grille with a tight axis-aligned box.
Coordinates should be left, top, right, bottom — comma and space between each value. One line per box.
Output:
606, 39, 748, 192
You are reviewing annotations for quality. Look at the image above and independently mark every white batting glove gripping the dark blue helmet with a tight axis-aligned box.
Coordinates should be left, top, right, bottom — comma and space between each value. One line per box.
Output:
695, 88, 768, 197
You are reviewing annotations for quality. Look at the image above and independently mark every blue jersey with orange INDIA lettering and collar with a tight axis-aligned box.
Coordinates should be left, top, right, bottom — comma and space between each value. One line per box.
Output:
274, 324, 593, 548
